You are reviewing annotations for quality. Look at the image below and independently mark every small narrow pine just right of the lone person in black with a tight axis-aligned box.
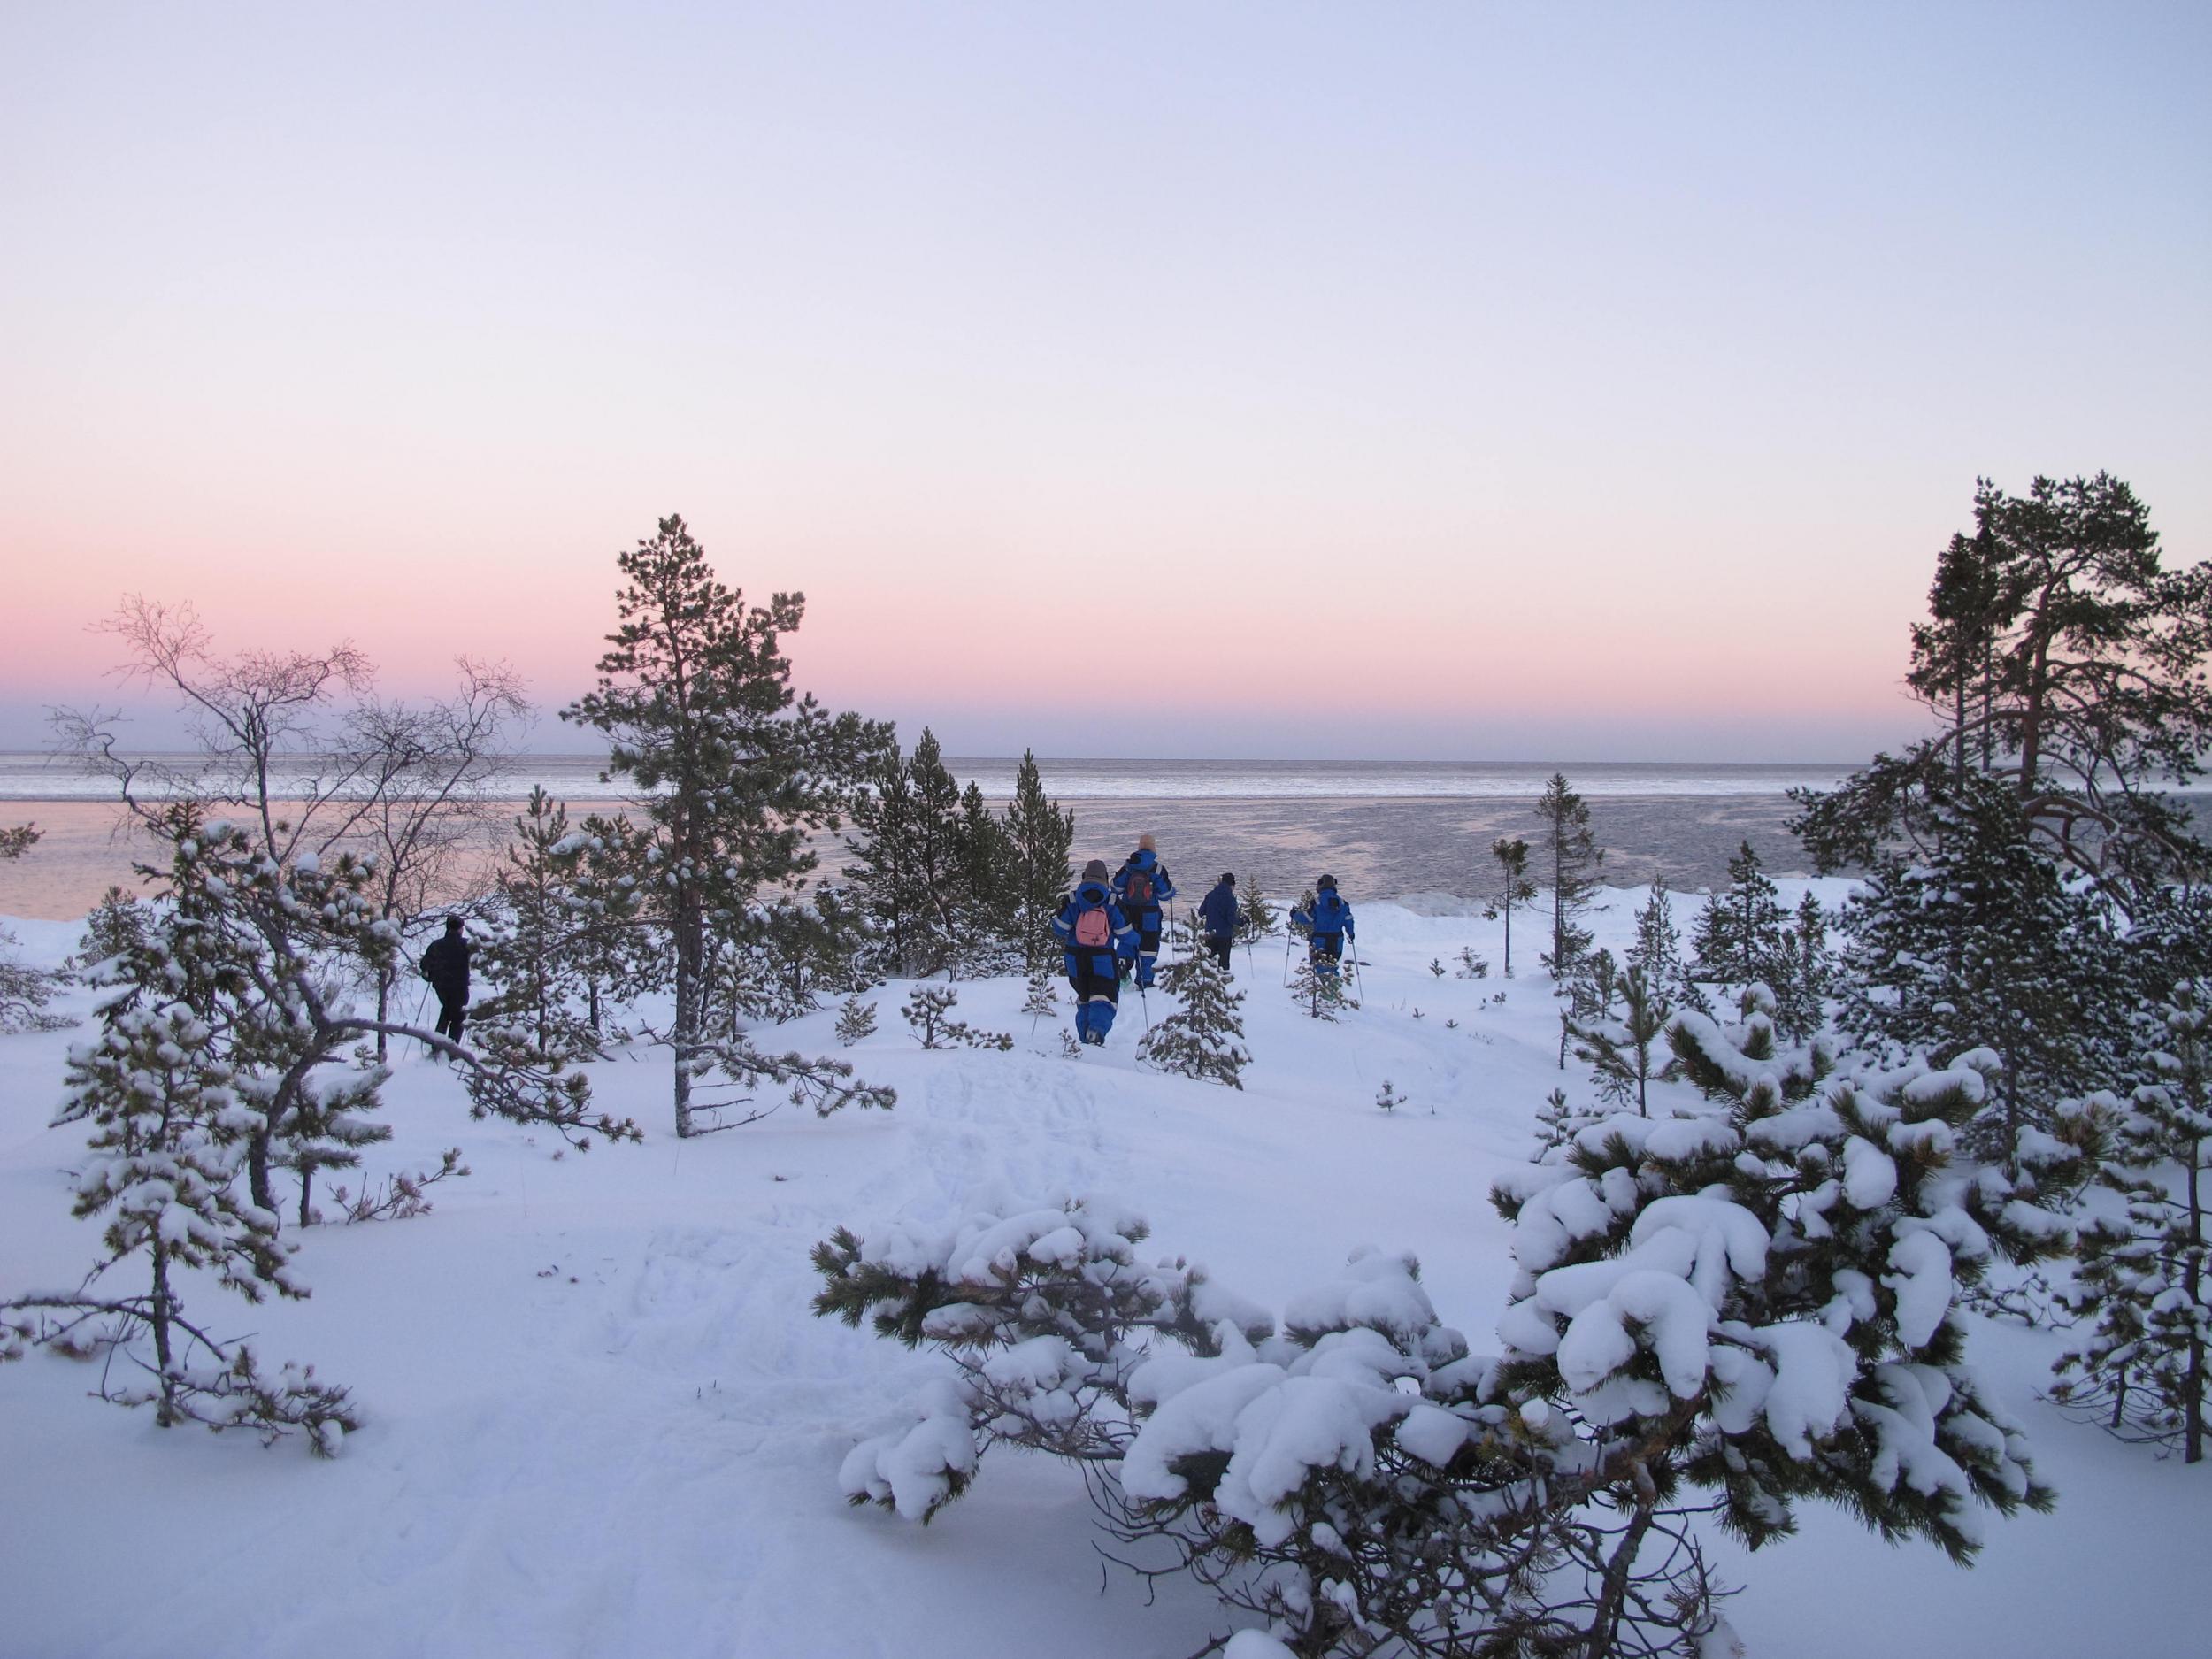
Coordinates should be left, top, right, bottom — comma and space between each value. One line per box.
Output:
469, 786, 604, 1060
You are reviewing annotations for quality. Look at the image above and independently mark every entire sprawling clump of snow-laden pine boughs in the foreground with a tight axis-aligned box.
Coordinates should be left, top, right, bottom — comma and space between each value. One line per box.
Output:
832, 1020, 2079, 1659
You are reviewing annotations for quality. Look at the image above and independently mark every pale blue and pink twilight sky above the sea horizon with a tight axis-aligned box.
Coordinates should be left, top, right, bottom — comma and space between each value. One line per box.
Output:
0, 4, 2212, 761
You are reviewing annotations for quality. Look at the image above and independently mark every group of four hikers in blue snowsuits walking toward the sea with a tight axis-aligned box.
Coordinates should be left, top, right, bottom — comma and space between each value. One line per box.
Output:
1053, 836, 1356, 1047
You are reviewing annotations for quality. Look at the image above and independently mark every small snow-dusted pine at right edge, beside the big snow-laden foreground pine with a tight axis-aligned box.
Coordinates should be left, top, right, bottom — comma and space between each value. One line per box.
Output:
2051, 982, 2212, 1463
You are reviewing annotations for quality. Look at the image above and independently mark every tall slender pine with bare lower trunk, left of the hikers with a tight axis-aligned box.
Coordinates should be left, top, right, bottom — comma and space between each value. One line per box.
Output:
562, 518, 894, 1135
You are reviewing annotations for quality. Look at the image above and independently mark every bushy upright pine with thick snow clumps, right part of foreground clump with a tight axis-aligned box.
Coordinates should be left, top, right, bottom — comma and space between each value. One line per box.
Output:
1494, 1016, 2078, 1601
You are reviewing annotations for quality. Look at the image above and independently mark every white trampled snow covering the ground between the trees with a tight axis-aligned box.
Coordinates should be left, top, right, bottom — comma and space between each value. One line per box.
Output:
0, 898, 2212, 1659
